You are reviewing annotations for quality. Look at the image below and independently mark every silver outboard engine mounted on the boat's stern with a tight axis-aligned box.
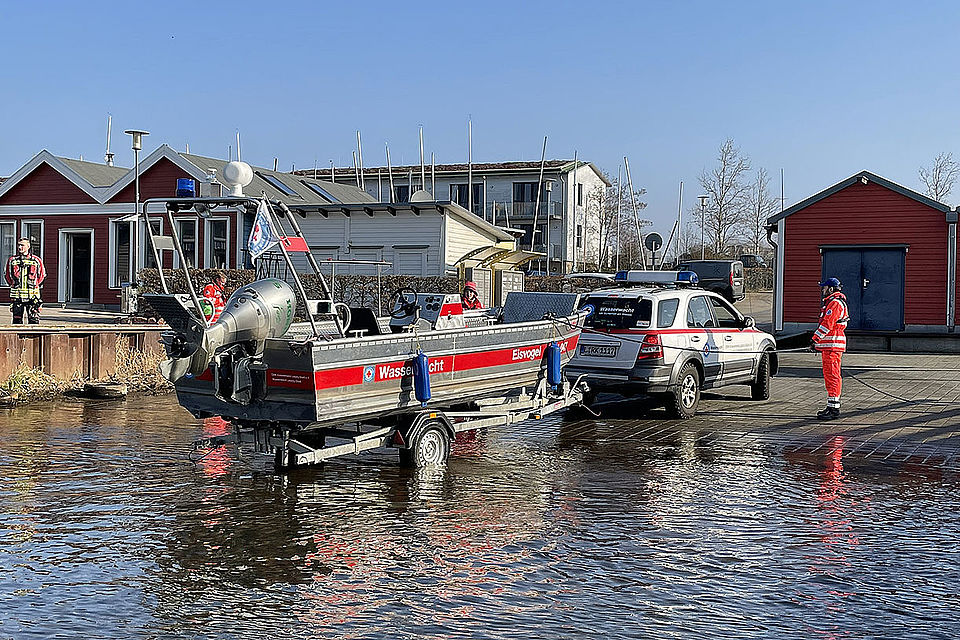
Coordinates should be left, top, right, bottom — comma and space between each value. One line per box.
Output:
144, 278, 297, 404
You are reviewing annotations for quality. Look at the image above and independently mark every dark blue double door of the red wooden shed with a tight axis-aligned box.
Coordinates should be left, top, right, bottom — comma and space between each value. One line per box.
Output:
822, 247, 906, 331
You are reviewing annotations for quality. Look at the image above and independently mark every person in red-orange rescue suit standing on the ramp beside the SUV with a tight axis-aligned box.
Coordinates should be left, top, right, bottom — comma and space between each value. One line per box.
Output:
810, 278, 850, 420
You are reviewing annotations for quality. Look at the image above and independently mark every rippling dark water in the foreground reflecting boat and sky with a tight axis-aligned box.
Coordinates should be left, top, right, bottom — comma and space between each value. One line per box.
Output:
0, 397, 960, 638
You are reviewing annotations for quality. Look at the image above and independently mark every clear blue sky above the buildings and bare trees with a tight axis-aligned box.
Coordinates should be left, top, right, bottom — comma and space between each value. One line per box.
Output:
0, 0, 960, 231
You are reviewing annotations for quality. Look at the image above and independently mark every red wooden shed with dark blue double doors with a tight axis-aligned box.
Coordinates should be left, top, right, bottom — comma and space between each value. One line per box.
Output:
767, 171, 957, 336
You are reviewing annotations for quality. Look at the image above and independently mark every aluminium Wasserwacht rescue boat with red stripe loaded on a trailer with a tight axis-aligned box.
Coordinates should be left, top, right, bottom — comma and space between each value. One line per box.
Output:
142, 184, 586, 432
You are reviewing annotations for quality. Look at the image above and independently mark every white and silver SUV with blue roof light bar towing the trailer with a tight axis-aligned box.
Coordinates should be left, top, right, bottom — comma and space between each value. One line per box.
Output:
566, 271, 778, 418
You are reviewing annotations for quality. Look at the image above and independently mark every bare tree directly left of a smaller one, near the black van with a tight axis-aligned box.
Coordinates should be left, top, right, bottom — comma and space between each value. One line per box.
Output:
698, 138, 750, 255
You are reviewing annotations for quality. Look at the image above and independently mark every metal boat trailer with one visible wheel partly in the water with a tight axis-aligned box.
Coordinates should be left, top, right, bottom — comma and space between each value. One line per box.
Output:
193, 377, 589, 470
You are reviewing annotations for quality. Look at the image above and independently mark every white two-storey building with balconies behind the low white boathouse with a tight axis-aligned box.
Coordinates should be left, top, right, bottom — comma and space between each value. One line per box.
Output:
298, 160, 611, 274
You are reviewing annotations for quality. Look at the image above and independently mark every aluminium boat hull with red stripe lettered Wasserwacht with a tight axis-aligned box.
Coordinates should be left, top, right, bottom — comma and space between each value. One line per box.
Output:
176, 314, 584, 427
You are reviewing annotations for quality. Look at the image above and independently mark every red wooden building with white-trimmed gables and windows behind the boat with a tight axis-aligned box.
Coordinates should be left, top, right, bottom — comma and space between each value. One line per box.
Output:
0, 145, 369, 306
